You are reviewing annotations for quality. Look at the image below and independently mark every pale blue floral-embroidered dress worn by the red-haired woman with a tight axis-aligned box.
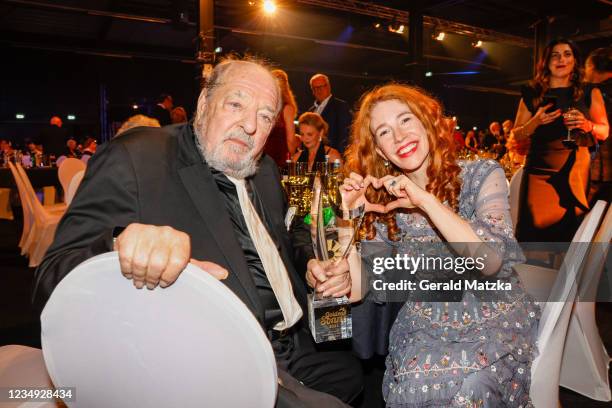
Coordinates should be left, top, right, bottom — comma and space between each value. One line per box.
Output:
375, 160, 540, 408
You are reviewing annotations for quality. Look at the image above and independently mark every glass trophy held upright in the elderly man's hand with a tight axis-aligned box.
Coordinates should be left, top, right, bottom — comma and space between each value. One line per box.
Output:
308, 172, 363, 343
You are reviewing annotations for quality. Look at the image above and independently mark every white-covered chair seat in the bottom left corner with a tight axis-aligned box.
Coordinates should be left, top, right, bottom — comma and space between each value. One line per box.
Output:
0, 345, 58, 408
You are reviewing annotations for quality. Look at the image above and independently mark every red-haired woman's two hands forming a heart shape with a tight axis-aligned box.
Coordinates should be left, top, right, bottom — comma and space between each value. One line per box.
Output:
340, 173, 430, 213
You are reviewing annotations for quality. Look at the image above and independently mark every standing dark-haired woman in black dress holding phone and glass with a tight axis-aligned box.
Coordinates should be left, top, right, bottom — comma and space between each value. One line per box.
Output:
513, 39, 608, 242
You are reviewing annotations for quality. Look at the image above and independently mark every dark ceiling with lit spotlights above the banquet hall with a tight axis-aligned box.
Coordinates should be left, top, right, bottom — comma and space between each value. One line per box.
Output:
0, 0, 612, 78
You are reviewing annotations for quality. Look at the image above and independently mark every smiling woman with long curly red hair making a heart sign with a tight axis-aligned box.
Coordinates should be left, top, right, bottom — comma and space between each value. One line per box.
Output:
340, 84, 540, 408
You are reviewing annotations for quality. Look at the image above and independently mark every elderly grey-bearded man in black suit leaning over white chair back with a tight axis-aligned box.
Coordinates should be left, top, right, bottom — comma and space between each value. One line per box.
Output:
34, 60, 362, 407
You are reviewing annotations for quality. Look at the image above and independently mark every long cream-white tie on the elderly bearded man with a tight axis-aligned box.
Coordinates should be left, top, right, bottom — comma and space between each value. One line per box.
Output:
227, 176, 302, 330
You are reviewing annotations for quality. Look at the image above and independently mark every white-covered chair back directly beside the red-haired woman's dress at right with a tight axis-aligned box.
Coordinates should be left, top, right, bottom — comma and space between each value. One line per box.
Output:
517, 201, 606, 408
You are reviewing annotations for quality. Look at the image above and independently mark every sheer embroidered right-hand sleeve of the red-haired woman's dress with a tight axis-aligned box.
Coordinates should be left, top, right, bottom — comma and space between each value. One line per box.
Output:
468, 161, 524, 277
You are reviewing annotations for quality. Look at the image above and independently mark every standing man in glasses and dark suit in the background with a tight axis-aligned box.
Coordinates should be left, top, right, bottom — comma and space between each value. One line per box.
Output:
308, 74, 352, 153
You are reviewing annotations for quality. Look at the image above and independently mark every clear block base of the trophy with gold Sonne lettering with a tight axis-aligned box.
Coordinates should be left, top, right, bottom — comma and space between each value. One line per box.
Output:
308, 294, 353, 343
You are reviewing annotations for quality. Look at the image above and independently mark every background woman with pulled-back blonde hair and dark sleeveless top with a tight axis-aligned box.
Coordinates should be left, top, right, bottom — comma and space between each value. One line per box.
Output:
293, 112, 342, 171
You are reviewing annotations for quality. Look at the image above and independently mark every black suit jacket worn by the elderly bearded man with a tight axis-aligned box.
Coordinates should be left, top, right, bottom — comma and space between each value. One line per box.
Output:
33, 124, 312, 324
